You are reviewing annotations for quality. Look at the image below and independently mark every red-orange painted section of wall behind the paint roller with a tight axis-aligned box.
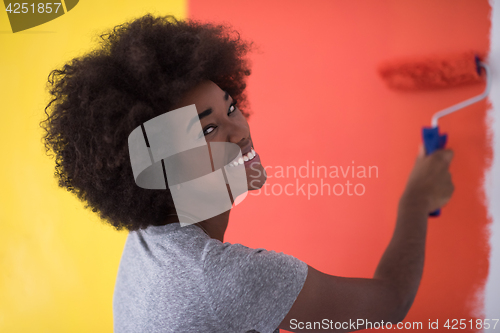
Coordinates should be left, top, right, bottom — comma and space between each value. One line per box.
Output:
189, 0, 491, 327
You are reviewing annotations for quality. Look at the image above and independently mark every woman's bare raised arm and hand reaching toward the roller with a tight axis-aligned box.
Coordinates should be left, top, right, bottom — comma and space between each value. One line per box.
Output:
279, 148, 454, 332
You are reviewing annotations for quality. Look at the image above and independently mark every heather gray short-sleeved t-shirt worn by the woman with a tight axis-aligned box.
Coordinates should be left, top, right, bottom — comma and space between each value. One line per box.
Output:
113, 223, 307, 333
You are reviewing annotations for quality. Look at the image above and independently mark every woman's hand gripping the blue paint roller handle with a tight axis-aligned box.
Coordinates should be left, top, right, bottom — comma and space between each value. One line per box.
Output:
401, 146, 455, 213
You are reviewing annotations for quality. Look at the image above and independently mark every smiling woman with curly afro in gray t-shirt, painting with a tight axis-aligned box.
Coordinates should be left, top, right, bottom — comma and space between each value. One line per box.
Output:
43, 15, 453, 333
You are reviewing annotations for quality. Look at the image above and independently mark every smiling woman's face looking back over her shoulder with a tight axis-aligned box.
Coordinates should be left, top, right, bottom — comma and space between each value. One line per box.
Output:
172, 81, 266, 190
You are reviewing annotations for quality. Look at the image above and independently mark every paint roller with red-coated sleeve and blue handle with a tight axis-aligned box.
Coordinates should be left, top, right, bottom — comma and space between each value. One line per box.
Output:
379, 52, 491, 216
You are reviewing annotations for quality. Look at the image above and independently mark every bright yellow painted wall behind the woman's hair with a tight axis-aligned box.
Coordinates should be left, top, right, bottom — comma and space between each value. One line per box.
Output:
0, 0, 187, 333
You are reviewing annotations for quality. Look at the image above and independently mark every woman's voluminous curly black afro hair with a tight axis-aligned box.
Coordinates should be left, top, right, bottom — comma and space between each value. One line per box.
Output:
40, 14, 255, 231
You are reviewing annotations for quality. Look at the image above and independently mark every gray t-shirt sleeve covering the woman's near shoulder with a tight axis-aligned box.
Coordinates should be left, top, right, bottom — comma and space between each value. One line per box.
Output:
204, 243, 307, 333
